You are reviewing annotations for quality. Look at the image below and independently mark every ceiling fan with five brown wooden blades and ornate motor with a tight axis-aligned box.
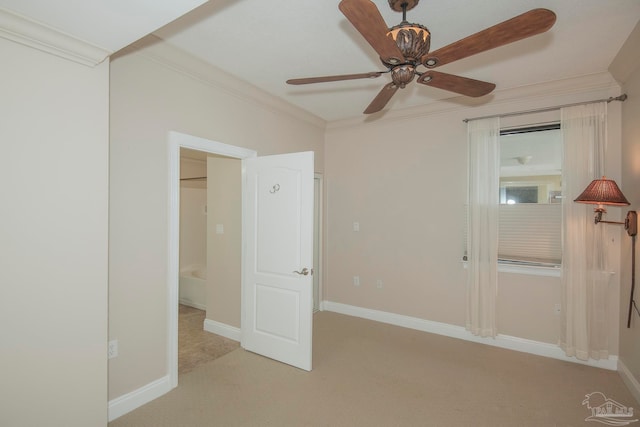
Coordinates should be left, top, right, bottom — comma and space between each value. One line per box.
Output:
287, 0, 556, 114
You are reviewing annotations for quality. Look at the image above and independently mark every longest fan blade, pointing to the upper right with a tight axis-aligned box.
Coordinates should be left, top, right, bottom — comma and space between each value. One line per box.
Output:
421, 9, 556, 68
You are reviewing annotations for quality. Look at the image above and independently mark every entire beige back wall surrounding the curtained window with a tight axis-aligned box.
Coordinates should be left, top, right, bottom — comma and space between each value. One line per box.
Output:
324, 76, 620, 354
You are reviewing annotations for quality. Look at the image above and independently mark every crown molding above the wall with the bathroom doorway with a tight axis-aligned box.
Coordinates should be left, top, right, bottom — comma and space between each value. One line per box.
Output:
119, 35, 326, 129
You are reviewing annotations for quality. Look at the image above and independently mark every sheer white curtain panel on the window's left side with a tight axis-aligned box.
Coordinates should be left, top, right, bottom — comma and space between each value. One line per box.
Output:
466, 118, 500, 337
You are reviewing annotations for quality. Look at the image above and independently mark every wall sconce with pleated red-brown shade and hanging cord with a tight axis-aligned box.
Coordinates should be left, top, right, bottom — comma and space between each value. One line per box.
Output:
574, 176, 640, 328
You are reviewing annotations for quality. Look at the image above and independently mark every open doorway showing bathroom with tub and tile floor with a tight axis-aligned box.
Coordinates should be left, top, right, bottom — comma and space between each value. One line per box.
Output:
178, 148, 241, 375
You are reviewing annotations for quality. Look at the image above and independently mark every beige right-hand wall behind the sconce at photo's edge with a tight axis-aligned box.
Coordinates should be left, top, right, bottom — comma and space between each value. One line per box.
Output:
614, 21, 640, 401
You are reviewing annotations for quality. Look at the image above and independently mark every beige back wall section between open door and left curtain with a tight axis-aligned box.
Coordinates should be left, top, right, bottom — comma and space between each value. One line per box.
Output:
324, 116, 466, 324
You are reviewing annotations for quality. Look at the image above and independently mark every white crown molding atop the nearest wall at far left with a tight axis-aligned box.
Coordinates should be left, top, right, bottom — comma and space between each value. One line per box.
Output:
0, 8, 113, 67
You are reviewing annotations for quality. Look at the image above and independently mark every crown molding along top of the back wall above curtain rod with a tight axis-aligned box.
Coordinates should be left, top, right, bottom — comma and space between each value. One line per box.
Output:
327, 72, 620, 131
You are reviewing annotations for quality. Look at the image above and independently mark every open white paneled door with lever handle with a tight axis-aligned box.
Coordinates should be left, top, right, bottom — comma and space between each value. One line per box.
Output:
241, 152, 314, 371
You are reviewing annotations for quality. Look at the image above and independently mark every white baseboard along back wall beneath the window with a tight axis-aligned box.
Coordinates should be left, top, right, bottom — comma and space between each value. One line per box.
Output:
322, 301, 618, 371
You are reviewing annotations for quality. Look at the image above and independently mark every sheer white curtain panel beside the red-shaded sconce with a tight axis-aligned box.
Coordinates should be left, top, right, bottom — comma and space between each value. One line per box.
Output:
560, 102, 610, 360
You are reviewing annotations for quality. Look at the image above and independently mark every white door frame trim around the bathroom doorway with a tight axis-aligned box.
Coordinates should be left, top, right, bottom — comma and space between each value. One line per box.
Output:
167, 131, 258, 388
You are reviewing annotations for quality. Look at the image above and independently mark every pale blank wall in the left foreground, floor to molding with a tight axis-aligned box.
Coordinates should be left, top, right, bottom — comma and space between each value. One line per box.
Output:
0, 38, 109, 427
